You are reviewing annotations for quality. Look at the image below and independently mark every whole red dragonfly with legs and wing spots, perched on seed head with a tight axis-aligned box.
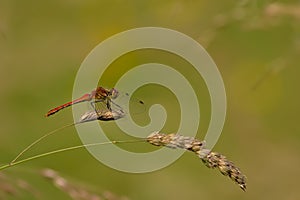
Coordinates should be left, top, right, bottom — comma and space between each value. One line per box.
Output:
45, 86, 144, 117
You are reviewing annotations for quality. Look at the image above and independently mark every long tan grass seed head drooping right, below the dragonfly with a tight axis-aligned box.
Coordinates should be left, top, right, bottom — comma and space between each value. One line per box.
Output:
147, 132, 246, 191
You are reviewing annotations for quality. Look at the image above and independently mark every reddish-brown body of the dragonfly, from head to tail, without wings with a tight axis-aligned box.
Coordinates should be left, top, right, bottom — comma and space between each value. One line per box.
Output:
45, 87, 118, 117
